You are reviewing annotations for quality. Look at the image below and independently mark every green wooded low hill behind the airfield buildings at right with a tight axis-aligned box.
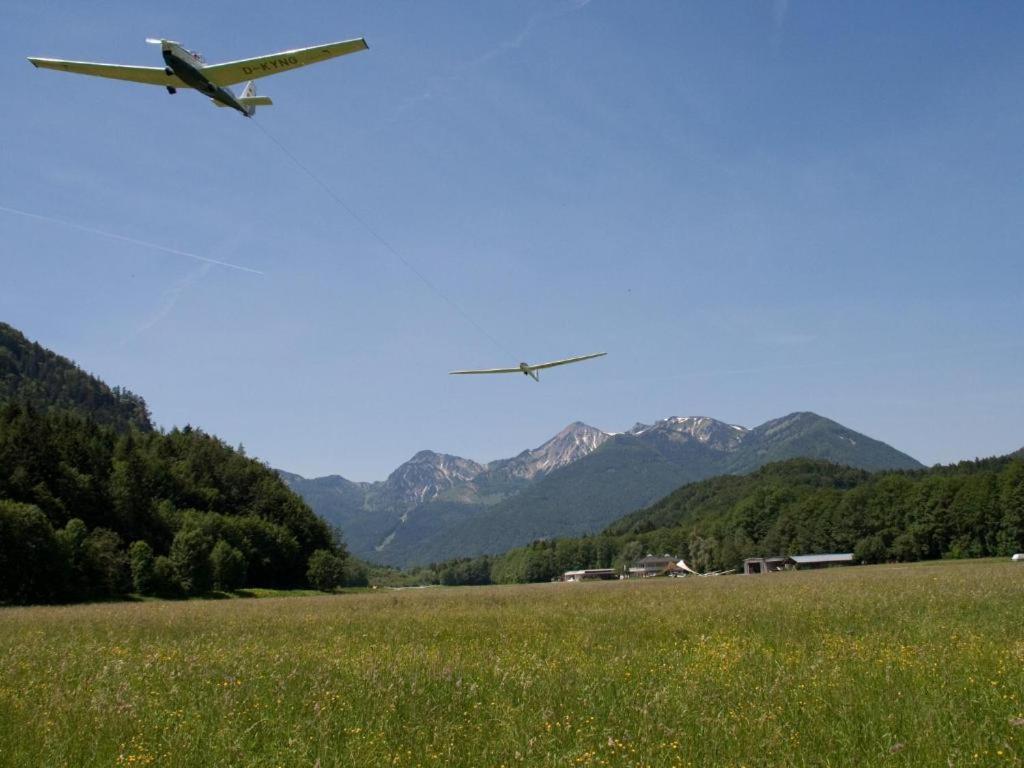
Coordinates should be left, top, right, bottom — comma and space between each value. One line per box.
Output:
404, 456, 1024, 584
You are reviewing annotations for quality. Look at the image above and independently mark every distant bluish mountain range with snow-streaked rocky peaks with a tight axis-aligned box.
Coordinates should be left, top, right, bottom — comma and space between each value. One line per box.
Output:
279, 413, 922, 566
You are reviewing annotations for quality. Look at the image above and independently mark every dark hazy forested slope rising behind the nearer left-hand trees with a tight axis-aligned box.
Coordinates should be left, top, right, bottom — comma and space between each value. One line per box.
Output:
0, 323, 153, 431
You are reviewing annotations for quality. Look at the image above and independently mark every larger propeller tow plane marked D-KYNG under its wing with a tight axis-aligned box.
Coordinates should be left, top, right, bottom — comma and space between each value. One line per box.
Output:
29, 37, 370, 118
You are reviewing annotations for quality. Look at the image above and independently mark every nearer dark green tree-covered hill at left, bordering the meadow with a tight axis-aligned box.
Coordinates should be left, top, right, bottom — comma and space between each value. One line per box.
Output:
0, 402, 356, 603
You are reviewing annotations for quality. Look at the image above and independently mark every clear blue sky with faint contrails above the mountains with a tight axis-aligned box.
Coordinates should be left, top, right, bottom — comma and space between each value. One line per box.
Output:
0, 0, 1024, 479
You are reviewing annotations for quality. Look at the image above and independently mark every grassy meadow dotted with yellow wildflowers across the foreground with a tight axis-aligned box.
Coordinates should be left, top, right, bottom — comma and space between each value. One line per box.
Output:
0, 562, 1024, 768
